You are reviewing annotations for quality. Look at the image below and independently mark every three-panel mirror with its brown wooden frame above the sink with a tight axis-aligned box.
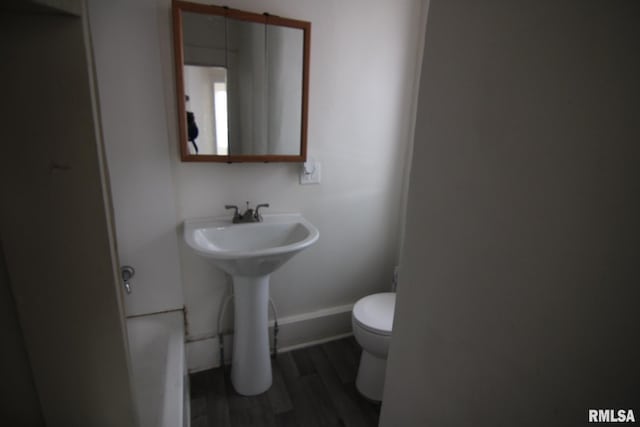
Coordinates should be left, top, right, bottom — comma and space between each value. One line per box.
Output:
173, 0, 311, 163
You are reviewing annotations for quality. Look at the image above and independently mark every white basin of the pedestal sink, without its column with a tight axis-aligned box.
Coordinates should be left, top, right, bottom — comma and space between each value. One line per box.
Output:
184, 214, 319, 276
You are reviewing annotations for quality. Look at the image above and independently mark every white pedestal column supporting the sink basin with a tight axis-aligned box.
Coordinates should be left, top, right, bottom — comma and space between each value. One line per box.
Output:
231, 275, 272, 396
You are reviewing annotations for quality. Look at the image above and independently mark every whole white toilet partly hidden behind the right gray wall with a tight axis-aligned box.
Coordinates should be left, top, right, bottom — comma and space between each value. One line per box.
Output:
351, 292, 396, 401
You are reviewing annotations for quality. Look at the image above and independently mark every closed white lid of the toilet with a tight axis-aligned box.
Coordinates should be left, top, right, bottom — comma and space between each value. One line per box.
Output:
353, 292, 396, 335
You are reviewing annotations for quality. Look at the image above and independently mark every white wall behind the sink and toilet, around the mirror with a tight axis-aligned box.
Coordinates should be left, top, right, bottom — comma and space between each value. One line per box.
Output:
170, 0, 428, 368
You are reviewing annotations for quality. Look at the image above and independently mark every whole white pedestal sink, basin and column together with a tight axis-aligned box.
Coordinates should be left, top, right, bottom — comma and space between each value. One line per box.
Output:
184, 214, 319, 396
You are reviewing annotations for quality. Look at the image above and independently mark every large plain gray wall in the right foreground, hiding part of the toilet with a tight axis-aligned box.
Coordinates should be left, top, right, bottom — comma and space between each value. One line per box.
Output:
381, 0, 640, 426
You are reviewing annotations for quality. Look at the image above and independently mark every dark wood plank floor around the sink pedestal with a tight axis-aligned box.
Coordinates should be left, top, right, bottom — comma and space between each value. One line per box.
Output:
190, 337, 380, 427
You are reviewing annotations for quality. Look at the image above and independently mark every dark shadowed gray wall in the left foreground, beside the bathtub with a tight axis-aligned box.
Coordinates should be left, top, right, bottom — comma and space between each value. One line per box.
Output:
0, 10, 137, 427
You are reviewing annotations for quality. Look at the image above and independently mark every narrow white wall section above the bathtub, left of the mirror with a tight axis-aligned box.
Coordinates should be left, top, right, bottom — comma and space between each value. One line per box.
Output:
88, 0, 184, 316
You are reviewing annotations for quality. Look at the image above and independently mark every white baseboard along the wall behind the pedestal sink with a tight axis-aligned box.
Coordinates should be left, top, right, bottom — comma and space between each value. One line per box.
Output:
187, 304, 353, 372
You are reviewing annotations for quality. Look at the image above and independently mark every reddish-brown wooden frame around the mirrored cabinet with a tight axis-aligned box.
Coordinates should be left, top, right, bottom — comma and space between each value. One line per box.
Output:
172, 0, 311, 163
